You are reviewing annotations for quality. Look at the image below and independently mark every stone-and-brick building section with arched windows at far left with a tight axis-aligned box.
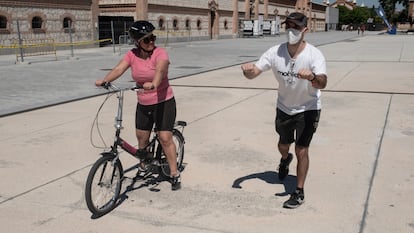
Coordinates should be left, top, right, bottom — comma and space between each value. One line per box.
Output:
0, 0, 97, 46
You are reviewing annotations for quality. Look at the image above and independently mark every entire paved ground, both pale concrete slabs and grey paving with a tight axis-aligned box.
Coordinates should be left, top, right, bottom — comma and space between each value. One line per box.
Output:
0, 32, 414, 233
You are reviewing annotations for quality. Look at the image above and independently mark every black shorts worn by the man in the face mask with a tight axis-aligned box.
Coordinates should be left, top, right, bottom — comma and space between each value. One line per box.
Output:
275, 109, 321, 147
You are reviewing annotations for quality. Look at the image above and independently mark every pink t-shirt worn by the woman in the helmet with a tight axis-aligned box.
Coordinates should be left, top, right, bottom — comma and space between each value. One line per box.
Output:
124, 47, 174, 105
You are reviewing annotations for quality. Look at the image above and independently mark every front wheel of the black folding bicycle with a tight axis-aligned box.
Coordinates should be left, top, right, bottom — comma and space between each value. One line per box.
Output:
85, 156, 123, 216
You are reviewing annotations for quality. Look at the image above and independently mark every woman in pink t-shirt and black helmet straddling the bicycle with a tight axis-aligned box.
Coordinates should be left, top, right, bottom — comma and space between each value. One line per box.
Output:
95, 21, 181, 190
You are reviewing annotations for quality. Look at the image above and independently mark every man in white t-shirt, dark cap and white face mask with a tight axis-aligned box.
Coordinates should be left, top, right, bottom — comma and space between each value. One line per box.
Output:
241, 12, 327, 208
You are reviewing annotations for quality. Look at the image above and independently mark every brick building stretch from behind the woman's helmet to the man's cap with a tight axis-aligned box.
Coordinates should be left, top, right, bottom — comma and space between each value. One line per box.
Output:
99, 0, 326, 39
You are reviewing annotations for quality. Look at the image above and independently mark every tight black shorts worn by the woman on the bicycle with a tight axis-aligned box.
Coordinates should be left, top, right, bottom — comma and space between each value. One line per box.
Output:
135, 98, 177, 131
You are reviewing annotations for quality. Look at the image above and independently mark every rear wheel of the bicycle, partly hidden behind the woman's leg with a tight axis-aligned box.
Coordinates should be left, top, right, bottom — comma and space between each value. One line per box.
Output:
157, 129, 185, 177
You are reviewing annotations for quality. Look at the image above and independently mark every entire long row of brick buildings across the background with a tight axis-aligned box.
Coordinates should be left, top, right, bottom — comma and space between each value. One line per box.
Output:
0, 0, 326, 51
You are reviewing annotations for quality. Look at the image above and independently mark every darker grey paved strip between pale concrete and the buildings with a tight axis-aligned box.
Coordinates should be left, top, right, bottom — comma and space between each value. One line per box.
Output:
0, 31, 368, 117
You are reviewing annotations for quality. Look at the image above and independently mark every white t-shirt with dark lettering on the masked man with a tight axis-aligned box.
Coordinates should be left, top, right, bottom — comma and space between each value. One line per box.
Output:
255, 43, 326, 115
